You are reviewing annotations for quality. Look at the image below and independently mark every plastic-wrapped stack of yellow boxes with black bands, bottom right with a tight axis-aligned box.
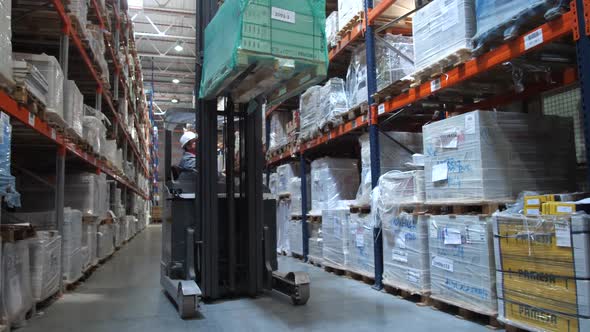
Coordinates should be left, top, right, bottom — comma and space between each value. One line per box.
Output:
494, 212, 590, 332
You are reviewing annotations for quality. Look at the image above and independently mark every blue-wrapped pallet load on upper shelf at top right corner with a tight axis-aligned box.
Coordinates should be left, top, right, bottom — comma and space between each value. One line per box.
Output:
473, 0, 569, 51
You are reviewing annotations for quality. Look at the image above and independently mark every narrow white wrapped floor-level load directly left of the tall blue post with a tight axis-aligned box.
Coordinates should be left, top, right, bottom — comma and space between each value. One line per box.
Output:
346, 213, 375, 278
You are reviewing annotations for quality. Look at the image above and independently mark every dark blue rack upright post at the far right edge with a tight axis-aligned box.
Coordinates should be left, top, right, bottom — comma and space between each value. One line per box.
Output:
576, 0, 590, 183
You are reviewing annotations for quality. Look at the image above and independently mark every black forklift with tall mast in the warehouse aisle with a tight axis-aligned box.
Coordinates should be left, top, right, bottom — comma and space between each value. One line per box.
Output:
160, 0, 310, 319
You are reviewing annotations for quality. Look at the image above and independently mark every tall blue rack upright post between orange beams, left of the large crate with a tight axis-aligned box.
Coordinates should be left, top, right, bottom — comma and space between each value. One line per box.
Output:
365, 0, 383, 290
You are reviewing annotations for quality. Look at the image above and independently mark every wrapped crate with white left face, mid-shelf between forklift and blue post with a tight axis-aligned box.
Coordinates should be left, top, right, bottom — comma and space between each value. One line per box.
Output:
310, 157, 359, 215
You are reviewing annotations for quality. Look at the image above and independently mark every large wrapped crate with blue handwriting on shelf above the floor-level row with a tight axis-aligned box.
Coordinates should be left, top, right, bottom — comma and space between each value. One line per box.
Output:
423, 111, 576, 203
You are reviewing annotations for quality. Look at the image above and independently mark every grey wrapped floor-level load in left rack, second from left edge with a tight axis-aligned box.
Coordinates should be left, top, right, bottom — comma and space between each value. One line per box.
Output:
30, 231, 62, 302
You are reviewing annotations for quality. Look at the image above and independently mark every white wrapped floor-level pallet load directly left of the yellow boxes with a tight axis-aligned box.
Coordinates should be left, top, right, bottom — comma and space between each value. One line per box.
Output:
428, 215, 498, 315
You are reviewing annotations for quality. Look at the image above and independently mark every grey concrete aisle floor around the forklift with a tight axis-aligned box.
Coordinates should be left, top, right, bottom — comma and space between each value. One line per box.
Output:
19, 226, 498, 332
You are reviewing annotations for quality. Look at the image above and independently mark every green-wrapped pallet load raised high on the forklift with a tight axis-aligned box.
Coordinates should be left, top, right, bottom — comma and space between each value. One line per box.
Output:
199, 0, 328, 102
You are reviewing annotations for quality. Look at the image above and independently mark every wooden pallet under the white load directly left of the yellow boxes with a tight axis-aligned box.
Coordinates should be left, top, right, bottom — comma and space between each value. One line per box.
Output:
430, 295, 503, 330
